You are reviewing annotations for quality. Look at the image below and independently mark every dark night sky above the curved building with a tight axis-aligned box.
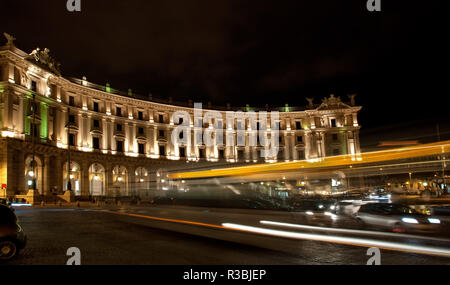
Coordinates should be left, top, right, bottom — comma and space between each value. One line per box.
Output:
0, 0, 449, 143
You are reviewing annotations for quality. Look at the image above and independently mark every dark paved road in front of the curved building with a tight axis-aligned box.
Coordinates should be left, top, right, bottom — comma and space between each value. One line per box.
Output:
3, 206, 450, 265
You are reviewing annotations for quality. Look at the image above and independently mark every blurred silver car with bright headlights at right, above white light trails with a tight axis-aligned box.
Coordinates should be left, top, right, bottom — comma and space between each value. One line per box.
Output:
355, 203, 441, 232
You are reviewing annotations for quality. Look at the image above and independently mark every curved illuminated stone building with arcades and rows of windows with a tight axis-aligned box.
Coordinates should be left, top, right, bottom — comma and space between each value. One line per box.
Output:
0, 34, 361, 200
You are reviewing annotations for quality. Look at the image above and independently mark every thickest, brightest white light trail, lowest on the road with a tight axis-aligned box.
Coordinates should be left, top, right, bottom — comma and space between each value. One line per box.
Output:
222, 223, 450, 257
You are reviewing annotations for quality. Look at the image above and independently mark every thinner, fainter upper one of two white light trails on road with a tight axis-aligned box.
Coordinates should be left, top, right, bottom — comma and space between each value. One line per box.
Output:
260, 221, 450, 242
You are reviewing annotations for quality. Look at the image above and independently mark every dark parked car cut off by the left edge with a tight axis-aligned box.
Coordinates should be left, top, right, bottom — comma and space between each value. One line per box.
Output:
0, 204, 27, 261
